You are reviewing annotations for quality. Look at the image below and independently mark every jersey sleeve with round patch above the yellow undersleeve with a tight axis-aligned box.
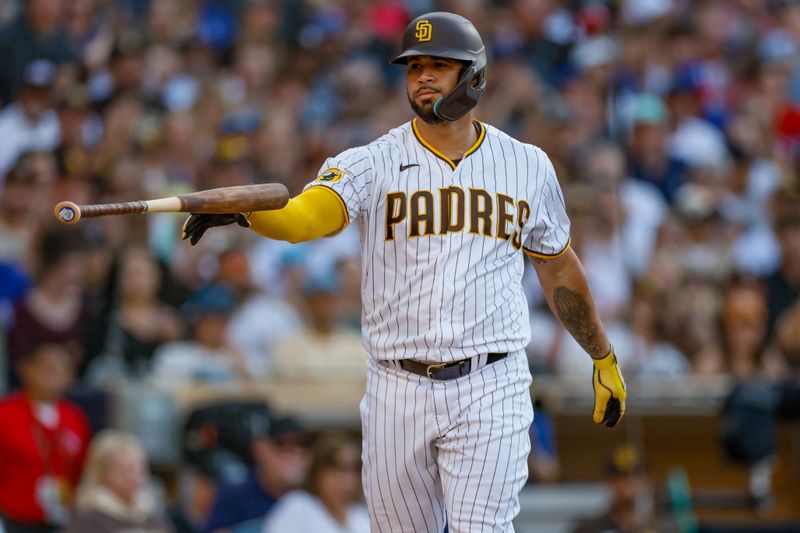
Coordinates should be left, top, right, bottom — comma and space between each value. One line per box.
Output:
304, 147, 374, 226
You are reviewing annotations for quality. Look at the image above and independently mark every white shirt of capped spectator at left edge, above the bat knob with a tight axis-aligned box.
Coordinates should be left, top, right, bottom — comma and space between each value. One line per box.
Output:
0, 104, 61, 181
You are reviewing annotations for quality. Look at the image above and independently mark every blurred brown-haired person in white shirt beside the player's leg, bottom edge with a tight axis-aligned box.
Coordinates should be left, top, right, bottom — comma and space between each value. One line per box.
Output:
263, 433, 370, 533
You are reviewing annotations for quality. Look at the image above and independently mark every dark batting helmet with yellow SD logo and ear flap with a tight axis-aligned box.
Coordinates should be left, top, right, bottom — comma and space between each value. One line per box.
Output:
392, 11, 486, 121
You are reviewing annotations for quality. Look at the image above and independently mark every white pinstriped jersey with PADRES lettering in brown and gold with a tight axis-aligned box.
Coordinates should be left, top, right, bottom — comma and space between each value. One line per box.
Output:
307, 119, 569, 362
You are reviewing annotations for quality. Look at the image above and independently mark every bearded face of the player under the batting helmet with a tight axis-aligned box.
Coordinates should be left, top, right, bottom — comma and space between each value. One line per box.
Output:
406, 56, 462, 124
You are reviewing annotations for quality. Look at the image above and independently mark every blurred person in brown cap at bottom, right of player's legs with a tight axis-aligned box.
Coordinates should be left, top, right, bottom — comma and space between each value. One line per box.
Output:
572, 444, 662, 533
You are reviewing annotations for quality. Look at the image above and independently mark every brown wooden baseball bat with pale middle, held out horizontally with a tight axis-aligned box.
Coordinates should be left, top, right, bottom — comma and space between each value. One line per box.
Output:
53, 183, 289, 224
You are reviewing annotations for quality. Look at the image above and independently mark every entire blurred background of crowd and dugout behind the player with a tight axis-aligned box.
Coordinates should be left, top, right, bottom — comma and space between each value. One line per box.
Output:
0, 0, 800, 533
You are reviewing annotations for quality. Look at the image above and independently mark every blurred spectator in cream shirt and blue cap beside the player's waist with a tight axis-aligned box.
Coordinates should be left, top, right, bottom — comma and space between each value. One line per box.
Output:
273, 274, 366, 381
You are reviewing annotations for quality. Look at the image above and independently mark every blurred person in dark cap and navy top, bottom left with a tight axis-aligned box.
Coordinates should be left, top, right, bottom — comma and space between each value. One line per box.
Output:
203, 417, 308, 533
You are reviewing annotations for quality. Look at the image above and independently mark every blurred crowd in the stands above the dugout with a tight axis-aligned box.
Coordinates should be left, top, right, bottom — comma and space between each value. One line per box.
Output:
0, 0, 800, 520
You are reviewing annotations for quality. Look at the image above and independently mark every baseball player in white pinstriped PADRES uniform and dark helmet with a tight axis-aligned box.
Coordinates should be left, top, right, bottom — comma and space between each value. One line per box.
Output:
183, 12, 626, 533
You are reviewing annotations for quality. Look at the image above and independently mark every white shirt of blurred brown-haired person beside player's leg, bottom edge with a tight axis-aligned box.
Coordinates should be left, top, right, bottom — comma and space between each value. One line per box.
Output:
262, 491, 369, 533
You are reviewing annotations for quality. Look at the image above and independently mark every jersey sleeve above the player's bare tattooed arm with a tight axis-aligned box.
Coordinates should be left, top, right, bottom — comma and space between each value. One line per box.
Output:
522, 150, 570, 259
